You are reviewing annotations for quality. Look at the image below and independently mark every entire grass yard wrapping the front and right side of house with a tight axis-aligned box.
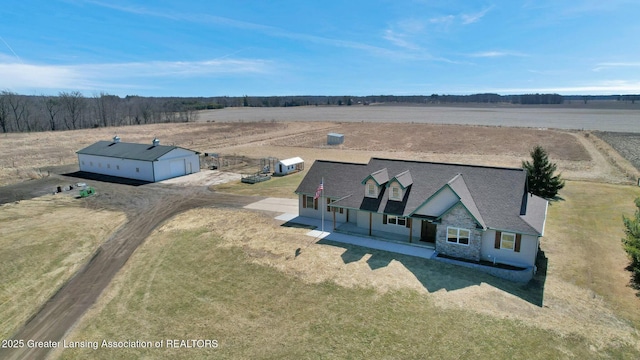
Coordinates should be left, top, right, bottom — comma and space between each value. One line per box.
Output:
56, 182, 640, 359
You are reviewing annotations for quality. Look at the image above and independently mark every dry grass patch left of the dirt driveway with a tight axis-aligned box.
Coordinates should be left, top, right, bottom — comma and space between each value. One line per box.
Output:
0, 195, 125, 338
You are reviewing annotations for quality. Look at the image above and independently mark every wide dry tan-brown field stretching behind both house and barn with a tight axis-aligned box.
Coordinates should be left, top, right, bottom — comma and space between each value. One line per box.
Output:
0, 121, 629, 185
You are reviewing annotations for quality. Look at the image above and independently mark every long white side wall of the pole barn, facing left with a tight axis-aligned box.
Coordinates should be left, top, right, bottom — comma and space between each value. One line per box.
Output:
78, 154, 153, 182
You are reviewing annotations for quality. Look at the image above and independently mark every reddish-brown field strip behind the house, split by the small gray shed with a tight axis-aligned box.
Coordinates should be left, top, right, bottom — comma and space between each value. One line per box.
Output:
270, 123, 591, 161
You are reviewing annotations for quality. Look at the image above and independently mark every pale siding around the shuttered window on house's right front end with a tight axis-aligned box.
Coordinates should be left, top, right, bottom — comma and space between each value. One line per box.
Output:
480, 230, 538, 267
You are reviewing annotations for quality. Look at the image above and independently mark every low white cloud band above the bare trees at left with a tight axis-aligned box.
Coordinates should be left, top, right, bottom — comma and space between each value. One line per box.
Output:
0, 57, 273, 91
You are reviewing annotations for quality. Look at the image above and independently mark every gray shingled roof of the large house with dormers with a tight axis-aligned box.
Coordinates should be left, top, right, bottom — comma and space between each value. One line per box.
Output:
296, 158, 547, 235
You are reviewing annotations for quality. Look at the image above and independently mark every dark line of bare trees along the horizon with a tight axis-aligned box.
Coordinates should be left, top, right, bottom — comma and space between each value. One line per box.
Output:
0, 91, 640, 133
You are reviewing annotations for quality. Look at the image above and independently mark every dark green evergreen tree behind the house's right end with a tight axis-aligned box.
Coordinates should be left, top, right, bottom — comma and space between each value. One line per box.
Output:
522, 145, 564, 200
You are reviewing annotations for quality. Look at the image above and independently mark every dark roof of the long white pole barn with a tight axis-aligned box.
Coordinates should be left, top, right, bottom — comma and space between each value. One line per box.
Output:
76, 141, 197, 161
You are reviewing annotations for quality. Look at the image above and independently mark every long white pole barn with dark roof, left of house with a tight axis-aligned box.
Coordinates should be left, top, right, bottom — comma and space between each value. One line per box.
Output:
76, 136, 200, 182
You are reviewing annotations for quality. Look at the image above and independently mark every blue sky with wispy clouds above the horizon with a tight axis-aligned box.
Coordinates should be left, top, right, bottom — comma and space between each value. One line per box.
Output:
0, 0, 640, 96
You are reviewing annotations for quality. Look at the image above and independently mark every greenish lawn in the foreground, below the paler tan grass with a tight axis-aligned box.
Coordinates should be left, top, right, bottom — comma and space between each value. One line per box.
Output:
57, 224, 640, 359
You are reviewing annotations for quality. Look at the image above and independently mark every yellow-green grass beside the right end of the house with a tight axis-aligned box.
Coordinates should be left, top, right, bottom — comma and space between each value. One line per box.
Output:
541, 181, 640, 329
